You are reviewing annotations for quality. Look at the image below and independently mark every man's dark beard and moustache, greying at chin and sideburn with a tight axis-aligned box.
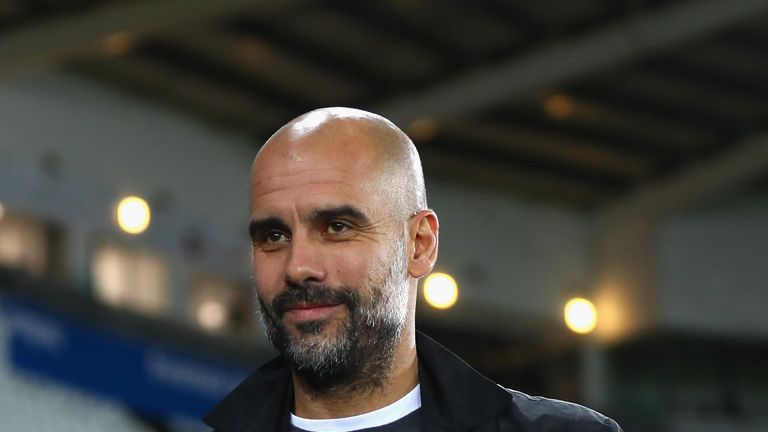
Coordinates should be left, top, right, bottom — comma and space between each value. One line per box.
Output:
259, 236, 408, 397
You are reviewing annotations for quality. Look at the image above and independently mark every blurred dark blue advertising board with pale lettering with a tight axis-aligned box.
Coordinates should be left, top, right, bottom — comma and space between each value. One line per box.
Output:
4, 298, 247, 419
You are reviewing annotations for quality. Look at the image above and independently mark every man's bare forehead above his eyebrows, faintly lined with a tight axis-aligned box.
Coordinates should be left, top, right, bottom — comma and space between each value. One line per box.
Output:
250, 123, 381, 215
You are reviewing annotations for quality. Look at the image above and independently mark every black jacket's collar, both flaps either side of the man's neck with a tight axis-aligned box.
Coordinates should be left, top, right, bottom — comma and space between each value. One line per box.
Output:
204, 332, 511, 432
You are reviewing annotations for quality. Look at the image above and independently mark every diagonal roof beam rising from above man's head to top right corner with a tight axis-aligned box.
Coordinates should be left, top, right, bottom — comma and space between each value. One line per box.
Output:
372, 0, 768, 126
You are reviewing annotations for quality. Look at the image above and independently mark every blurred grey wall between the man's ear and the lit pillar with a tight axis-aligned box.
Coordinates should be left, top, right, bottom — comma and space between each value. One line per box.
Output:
427, 181, 592, 331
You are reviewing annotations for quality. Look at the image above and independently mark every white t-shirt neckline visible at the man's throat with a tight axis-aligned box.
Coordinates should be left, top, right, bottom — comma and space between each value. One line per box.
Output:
291, 384, 421, 432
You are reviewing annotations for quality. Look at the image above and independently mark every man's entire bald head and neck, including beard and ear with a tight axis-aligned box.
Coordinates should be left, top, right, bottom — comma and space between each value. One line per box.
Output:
250, 108, 437, 418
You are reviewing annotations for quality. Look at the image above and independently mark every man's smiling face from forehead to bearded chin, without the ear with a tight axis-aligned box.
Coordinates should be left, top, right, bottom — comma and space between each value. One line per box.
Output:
250, 120, 409, 391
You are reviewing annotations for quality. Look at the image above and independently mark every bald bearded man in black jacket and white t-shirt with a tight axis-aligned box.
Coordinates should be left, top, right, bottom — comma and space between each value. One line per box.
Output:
205, 108, 621, 432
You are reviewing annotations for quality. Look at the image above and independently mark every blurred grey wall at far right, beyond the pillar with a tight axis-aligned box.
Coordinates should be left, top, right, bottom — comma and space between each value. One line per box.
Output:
658, 196, 768, 336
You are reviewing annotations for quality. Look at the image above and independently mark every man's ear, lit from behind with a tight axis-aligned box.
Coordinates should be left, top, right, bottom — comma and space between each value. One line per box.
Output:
408, 210, 440, 279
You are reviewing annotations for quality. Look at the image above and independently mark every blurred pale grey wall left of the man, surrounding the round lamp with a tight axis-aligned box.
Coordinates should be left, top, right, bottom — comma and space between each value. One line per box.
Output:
0, 73, 256, 318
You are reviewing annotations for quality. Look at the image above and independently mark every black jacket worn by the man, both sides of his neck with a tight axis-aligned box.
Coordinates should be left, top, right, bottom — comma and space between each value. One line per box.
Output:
204, 333, 621, 432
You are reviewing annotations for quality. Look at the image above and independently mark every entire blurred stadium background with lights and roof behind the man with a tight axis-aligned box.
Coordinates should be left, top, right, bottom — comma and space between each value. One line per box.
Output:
0, 0, 768, 432
